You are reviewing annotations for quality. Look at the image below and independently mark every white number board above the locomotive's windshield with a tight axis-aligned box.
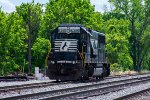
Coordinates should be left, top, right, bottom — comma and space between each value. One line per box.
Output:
58, 27, 80, 34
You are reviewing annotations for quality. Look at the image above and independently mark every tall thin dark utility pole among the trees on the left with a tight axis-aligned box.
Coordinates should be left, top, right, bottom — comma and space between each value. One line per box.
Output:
28, 5, 32, 74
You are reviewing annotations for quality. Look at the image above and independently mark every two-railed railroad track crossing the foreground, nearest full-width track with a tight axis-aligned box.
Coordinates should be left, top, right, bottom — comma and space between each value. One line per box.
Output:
2, 76, 150, 100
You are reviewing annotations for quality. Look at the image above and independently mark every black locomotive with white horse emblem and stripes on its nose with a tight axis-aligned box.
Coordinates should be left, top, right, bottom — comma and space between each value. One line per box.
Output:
46, 24, 110, 81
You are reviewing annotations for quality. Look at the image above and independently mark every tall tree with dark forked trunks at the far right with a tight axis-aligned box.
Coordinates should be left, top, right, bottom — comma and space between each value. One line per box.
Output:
109, 0, 150, 71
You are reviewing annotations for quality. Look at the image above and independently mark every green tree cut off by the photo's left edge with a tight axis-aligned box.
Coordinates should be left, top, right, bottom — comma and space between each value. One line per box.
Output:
0, 9, 11, 75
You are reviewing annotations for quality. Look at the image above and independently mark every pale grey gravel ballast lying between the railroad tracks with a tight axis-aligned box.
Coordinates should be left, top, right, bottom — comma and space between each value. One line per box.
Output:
0, 75, 150, 100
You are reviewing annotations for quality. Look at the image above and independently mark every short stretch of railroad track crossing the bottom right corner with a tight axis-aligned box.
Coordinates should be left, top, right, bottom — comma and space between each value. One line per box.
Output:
115, 88, 150, 100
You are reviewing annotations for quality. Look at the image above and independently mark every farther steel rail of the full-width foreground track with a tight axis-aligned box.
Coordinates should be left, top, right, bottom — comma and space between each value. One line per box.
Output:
1, 77, 150, 100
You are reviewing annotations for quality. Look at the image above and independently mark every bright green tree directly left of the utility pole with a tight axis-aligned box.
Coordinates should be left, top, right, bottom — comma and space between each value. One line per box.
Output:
6, 12, 27, 71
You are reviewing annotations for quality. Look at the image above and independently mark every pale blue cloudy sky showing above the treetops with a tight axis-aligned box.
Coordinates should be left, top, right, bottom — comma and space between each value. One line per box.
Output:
0, 0, 109, 13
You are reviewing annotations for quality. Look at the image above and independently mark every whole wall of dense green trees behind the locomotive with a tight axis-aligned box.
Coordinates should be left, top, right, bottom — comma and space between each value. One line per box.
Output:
0, 0, 150, 75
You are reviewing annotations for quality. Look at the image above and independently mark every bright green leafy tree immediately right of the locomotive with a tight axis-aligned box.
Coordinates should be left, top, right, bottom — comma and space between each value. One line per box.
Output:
103, 19, 133, 70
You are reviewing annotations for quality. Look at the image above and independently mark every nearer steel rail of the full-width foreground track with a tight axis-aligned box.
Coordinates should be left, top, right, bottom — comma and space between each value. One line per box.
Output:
39, 78, 150, 100
